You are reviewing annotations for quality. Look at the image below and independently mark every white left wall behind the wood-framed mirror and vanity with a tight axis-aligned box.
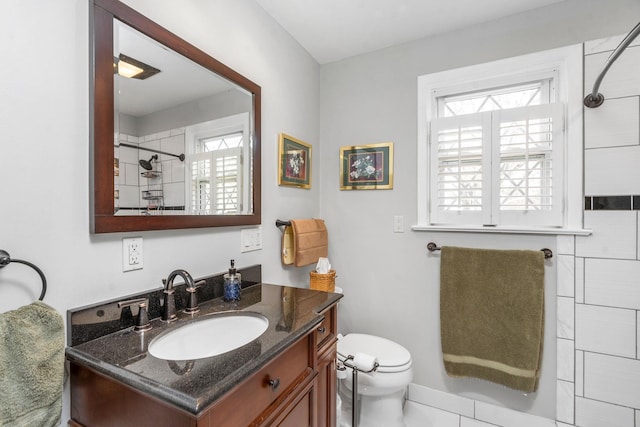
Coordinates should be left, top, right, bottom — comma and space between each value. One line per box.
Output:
0, 0, 320, 422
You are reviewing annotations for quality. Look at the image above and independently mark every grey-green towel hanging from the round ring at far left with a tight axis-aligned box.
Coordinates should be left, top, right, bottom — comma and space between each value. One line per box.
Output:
0, 301, 64, 427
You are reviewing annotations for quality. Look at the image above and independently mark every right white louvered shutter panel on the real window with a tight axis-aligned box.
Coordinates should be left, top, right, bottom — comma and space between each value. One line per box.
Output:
492, 103, 564, 226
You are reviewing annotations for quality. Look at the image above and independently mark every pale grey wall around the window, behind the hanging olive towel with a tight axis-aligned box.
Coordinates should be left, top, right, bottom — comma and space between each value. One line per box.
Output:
320, 0, 640, 419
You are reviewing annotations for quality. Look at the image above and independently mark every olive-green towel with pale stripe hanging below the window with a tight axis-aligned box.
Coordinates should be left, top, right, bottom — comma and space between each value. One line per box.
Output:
440, 247, 544, 392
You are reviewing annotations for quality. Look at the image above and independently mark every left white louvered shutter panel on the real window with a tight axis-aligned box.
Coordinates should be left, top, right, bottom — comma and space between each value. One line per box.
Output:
429, 113, 491, 224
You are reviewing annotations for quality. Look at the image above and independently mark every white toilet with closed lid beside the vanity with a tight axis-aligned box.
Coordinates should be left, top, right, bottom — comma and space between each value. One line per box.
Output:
338, 334, 413, 427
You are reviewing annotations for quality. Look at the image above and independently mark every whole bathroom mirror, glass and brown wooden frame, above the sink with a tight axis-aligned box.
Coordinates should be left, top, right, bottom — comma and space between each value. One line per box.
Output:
91, 0, 261, 233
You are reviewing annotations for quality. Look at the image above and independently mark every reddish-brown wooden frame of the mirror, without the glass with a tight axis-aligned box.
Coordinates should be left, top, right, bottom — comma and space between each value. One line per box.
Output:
90, 0, 261, 233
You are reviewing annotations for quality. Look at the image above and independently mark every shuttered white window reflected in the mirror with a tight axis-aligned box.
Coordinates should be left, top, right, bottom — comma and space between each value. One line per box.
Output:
187, 116, 248, 215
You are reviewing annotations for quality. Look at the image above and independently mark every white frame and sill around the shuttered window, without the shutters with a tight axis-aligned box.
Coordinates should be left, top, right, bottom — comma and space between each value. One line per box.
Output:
412, 45, 586, 234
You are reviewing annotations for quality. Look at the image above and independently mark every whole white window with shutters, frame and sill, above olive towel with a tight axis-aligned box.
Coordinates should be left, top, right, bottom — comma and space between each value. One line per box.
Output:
414, 48, 582, 234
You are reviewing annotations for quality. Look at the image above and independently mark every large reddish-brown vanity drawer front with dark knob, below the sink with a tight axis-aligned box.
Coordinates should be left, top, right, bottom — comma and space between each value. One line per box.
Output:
210, 336, 313, 427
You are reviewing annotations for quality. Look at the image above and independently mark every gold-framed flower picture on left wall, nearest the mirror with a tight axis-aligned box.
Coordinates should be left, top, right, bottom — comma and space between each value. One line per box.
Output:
278, 133, 311, 188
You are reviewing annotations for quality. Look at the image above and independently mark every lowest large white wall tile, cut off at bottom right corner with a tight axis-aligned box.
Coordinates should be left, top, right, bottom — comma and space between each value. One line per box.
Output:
576, 397, 634, 427
